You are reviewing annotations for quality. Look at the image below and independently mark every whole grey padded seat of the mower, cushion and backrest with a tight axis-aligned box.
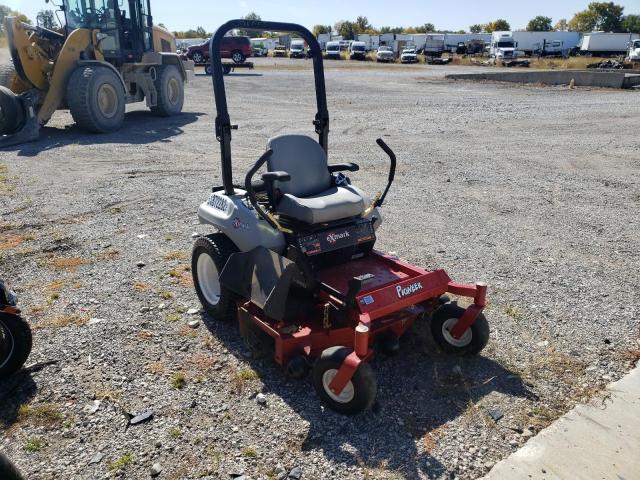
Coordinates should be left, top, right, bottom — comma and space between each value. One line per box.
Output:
267, 135, 365, 225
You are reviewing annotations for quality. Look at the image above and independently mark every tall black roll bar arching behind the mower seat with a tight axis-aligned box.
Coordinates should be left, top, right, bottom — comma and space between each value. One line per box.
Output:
209, 20, 329, 195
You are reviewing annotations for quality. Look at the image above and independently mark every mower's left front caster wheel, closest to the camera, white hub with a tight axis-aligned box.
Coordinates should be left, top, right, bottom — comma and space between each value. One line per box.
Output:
311, 347, 378, 415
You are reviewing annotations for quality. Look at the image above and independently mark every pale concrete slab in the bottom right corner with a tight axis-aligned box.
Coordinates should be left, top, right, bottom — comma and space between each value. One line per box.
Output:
484, 366, 640, 480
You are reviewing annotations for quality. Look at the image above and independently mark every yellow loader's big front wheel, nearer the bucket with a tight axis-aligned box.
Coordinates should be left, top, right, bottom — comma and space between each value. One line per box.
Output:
67, 66, 126, 133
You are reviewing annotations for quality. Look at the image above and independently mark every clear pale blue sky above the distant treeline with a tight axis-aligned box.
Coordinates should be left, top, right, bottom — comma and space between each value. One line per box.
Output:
7, 0, 640, 31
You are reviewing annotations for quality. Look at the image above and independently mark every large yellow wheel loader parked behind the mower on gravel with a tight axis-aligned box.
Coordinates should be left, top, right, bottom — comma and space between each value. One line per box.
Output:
0, 0, 193, 147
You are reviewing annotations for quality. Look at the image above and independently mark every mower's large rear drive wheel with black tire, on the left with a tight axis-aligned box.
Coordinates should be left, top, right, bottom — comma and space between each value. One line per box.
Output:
191, 233, 238, 321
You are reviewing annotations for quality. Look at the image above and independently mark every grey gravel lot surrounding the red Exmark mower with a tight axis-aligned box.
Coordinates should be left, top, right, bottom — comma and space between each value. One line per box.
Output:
0, 54, 640, 480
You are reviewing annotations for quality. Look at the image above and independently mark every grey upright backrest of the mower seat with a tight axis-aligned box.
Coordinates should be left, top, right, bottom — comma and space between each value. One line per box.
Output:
267, 135, 331, 197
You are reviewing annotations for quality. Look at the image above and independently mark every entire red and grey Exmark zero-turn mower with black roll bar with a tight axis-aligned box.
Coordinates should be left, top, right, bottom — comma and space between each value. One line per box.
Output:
192, 20, 489, 413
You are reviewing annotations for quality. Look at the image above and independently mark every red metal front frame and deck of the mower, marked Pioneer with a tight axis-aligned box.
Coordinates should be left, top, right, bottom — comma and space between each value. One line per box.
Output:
238, 251, 487, 402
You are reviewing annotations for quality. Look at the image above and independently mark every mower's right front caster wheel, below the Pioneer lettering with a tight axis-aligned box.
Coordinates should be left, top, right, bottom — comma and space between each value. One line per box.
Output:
431, 303, 489, 355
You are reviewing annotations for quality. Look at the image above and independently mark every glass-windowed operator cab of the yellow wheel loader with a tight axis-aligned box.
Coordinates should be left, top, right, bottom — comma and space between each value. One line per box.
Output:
61, 0, 153, 66
